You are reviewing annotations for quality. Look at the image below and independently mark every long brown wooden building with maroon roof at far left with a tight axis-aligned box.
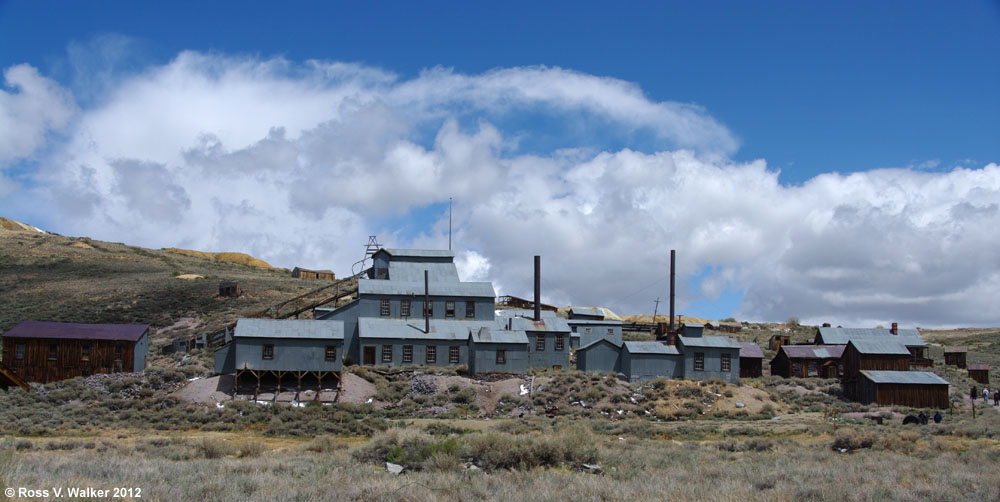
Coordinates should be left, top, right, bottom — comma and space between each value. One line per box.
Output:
3, 321, 149, 383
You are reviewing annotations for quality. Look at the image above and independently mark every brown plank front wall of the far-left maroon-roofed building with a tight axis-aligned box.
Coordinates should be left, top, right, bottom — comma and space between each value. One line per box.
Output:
3, 337, 135, 383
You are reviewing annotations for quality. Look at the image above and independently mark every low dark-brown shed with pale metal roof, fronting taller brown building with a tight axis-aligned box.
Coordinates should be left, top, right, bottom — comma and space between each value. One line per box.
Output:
857, 370, 949, 408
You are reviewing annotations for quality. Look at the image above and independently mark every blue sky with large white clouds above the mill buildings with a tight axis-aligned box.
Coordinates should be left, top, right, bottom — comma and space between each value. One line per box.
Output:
0, 0, 1000, 327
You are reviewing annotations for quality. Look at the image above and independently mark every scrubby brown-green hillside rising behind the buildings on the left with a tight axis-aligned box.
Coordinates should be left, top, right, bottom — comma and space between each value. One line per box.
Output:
0, 218, 329, 344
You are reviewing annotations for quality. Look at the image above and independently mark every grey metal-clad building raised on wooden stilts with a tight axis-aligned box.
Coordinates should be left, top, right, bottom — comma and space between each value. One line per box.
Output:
215, 319, 344, 392
